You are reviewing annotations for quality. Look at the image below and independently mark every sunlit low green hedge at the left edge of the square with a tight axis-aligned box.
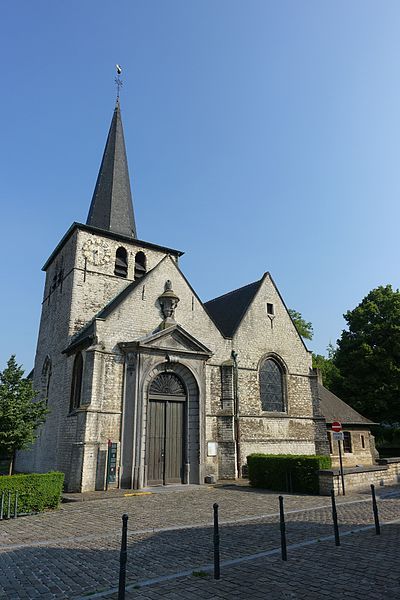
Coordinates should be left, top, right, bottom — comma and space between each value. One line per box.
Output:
0, 472, 64, 513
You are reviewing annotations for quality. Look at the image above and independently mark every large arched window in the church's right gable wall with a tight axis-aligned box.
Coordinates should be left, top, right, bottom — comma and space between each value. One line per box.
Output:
259, 358, 285, 412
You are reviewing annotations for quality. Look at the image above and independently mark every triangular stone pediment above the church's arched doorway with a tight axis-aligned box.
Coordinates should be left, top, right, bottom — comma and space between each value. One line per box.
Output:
120, 324, 212, 358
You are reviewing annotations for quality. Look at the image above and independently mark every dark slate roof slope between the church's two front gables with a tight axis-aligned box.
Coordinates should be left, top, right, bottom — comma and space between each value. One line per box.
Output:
204, 277, 264, 337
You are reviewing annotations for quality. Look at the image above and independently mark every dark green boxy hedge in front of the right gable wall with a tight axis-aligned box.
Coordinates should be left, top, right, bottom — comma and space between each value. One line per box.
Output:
247, 454, 331, 494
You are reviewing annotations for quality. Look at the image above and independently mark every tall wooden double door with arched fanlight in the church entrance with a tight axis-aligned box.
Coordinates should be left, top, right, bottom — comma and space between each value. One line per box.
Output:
146, 372, 187, 485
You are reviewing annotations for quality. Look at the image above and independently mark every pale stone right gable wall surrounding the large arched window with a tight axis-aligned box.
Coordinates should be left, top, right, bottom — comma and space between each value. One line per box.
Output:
232, 274, 327, 472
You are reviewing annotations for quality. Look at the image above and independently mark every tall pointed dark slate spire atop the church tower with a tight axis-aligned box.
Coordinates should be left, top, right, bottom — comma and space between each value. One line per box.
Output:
86, 98, 136, 238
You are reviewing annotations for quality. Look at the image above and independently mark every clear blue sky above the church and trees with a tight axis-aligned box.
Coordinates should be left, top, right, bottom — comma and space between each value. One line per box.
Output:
0, 0, 400, 370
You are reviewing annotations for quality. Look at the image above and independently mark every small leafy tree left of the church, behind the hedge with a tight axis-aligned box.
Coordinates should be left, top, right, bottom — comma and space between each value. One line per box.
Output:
0, 356, 49, 475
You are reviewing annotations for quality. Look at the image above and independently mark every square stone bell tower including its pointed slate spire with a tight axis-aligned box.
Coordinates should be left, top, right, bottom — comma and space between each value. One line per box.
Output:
17, 91, 182, 491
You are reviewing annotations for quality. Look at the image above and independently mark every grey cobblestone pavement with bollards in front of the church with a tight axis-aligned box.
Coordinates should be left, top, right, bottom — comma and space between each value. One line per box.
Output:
0, 486, 400, 600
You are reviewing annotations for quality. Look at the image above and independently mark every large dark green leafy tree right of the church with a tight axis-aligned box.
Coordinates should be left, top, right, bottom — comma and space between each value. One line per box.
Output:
332, 285, 400, 423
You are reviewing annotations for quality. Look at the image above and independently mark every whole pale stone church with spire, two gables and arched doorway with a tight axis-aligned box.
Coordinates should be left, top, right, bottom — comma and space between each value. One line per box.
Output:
17, 102, 329, 491
